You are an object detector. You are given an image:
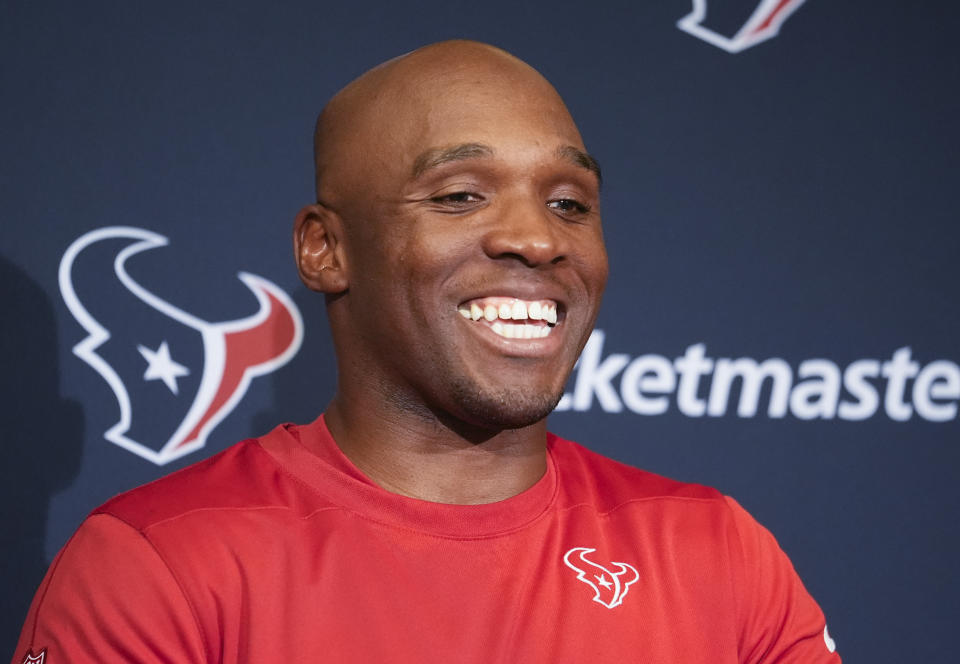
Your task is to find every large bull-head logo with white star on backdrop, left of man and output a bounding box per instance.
[59,226,303,465]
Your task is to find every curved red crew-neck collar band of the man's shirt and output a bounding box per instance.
[260,415,558,539]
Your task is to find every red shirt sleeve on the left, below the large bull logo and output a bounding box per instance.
[13,514,205,664]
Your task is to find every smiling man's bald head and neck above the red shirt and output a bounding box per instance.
[294,42,607,503]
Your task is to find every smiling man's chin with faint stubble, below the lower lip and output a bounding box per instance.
[451,378,563,429]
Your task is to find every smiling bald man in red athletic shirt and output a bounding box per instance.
[14,41,839,664]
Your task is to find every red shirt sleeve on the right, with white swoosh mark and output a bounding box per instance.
[726,497,840,664]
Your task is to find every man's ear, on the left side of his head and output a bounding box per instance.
[293,203,349,295]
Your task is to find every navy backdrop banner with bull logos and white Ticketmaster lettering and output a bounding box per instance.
[0,0,960,662]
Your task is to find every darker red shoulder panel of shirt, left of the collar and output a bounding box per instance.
[93,428,298,531]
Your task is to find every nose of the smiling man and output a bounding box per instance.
[484,197,566,267]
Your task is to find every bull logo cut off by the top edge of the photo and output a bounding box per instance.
[677,0,805,53]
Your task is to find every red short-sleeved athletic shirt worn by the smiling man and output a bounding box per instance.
[13,417,840,664]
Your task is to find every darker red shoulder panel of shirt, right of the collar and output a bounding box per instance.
[548,434,729,512]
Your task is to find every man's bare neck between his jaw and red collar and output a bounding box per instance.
[325,395,546,505]
